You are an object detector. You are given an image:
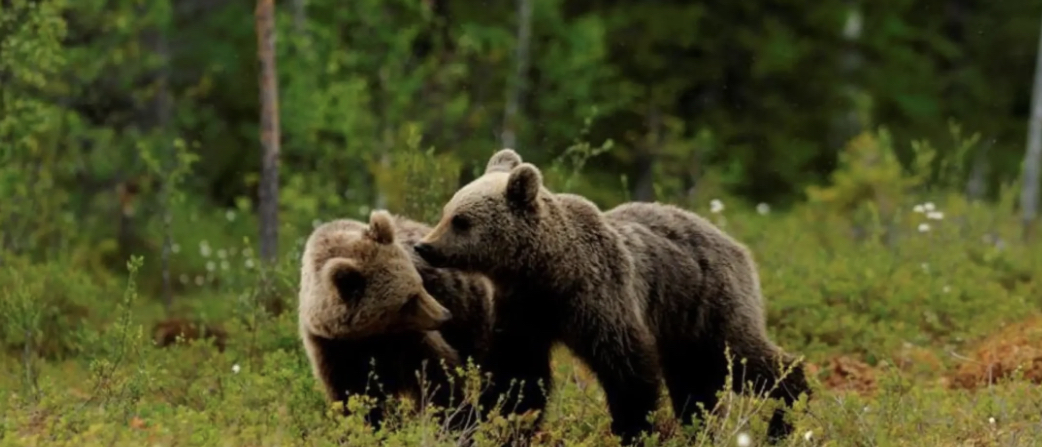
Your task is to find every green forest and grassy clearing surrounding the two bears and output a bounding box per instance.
[6,0,1042,447]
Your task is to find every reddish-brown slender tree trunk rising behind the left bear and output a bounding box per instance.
[255,0,279,264]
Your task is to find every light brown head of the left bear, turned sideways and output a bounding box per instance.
[300,210,451,339]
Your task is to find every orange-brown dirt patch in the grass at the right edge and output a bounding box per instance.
[950,317,1042,390]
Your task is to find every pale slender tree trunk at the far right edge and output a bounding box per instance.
[1020,14,1042,239]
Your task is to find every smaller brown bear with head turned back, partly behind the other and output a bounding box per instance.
[299,210,494,428]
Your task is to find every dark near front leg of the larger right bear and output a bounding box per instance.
[565,306,660,445]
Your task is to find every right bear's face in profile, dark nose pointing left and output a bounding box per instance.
[416,149,546,275]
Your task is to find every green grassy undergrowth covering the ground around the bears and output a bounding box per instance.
[6,130,1042,446]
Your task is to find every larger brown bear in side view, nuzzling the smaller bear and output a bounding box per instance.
[416,149,810,444]
